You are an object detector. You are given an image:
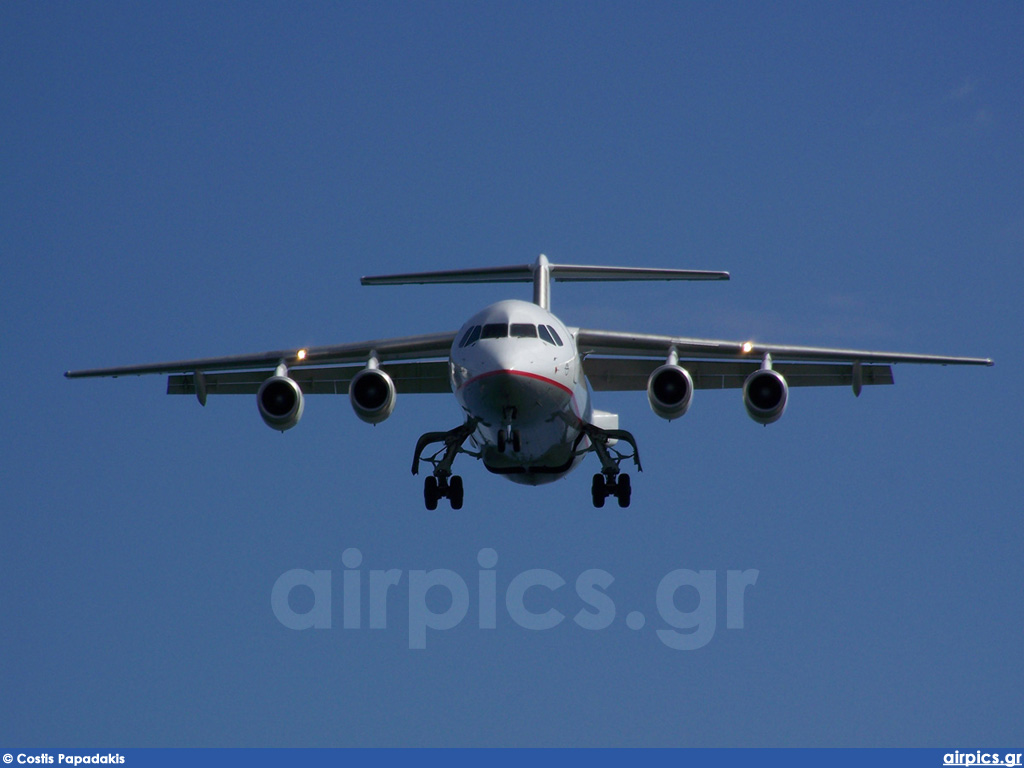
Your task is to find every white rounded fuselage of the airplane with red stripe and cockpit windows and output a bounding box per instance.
[449,300,592,485]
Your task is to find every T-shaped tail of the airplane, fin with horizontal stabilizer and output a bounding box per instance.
[359,253,729,310]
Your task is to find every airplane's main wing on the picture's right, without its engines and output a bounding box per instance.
[575,329,992,390]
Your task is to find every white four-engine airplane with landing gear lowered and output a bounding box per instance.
[65,254,992,510]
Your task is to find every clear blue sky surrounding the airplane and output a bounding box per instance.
[0,2,1024,749]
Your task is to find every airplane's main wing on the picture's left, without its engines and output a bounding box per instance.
[65,332,456,394]
